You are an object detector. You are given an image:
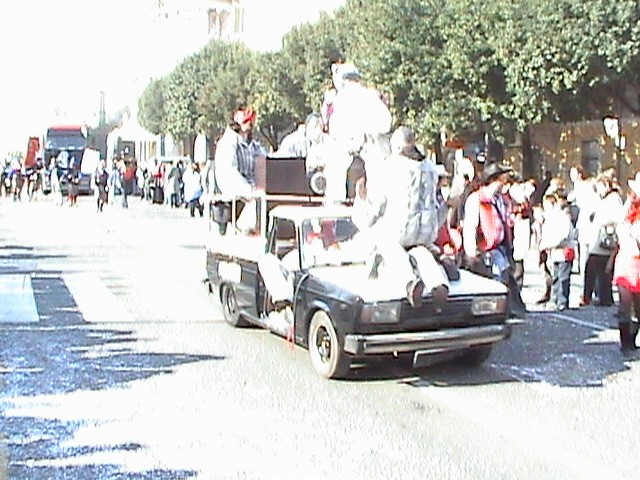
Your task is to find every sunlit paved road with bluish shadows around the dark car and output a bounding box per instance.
[0,193,640,480]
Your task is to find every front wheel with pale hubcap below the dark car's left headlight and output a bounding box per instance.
[308,311,351,378]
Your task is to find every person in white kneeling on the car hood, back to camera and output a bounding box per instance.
[353,127,450,310]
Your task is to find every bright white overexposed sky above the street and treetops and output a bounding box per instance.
[0,0,344,159]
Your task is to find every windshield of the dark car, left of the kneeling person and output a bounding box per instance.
[301,217,369,268]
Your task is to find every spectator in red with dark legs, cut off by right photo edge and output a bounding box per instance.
[612,172,640,350]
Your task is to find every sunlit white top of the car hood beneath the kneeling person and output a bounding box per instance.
[309,265,507,302]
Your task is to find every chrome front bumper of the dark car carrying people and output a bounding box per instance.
[344,324,511,355]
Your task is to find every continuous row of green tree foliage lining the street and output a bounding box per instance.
[139,0,640,156]
